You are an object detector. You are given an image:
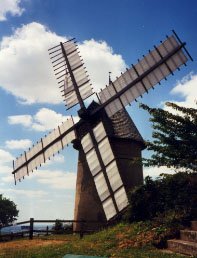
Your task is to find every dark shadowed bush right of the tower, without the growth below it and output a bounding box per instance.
[127,172,197,222]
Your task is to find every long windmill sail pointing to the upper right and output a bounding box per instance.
[99,35,190,117]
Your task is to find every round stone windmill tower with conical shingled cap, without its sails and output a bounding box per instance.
[74,102,145,230]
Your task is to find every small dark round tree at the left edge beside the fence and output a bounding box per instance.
[0,194,19,226]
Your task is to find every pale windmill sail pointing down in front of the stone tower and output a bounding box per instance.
[81,122,128,220]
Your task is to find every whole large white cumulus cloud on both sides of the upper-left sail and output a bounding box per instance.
[0,22,126,104]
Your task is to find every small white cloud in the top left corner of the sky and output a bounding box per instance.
[0,0,25,21]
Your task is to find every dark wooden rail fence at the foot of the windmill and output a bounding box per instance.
[0,218,107,240]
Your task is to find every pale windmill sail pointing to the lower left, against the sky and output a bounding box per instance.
[12,117,76,183]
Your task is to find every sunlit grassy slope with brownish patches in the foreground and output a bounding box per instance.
[0,223,189,258]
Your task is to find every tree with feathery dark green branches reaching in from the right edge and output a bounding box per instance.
[141,102,197,171]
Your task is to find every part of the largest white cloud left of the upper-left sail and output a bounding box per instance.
[0,22,65,104]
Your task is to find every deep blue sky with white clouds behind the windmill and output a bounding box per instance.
[0,0,197,221]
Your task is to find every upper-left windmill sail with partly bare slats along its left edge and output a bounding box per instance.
[49,39,94,108]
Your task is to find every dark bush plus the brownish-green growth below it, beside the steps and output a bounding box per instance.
[124,172,197,248]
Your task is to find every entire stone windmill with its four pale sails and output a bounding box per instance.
[12,31,192,230]
